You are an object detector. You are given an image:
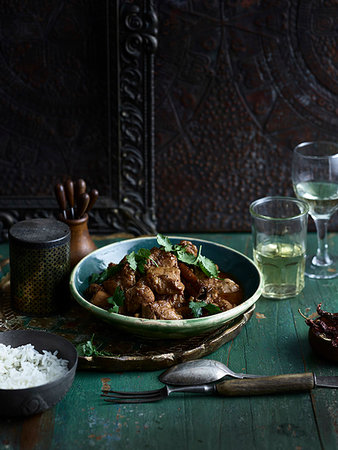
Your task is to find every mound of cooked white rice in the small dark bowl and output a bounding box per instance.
[0,344,68,389]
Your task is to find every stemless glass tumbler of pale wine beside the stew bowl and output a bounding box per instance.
[250,197,309,299]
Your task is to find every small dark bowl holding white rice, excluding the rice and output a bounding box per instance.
[0,330,78,417]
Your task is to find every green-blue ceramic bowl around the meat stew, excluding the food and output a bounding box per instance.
[70,236,262,339]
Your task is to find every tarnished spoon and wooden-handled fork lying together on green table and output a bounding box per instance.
[101,360,338,404]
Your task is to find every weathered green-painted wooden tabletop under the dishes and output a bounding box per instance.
[0,234,338,450]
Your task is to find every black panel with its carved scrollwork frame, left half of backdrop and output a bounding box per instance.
[0,0,157,241]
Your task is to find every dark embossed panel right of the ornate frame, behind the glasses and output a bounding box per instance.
[155,0,338,231]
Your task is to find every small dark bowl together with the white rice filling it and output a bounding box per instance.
[0,330,78,417]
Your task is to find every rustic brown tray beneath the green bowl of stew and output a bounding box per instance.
[0,275,255,372]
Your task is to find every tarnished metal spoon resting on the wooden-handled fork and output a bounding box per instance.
[159,359,261,386]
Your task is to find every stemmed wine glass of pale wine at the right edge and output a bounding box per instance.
[292,141,338,279]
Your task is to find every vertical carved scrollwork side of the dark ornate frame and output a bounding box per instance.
[119,1,157,232]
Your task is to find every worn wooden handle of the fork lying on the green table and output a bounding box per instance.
[216,373,315,396]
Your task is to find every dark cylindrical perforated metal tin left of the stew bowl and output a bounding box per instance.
[9,219,70,316]
